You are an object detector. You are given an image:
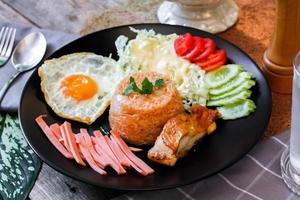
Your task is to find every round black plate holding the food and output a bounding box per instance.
[19,24,271,190]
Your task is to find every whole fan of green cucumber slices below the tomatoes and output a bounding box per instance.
[205,64,256,120]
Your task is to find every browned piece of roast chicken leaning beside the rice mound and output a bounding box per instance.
[148,105,220,166]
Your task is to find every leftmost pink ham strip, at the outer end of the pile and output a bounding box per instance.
[35,115,73,159]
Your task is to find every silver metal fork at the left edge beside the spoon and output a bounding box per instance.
[0,26,16,66]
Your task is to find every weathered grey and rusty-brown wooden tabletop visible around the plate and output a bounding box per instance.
[0,0,291,200]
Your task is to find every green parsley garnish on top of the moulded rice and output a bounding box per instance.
[123,76,164,96]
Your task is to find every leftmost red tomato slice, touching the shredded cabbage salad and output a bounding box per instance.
[174,33,194,56]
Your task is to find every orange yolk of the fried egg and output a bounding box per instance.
[60,74,97,101]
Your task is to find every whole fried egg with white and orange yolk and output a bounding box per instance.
[38,53,123,124]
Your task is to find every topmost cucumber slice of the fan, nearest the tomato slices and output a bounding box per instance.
[205,64,244,88]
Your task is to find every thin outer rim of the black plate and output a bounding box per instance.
[18,23,272,191]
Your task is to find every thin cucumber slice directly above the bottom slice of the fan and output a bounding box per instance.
[206,90,252,106]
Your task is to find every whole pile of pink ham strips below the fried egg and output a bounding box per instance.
[35,115,154,176]
